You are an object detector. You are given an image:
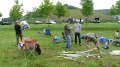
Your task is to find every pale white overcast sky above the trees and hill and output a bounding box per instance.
[0,0,118,17]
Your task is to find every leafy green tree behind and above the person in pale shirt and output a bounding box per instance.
[81,0,94,22]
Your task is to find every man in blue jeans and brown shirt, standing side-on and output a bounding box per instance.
[64,21,71,49]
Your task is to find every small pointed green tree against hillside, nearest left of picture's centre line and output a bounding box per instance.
[55,1,69,23]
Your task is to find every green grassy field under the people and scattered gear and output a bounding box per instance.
[0,24,120,67]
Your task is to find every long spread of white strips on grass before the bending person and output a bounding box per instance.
[58,49,100,60]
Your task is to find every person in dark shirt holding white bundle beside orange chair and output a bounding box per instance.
[14,21,22,45]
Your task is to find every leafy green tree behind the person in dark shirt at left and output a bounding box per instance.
[9,0,23,22]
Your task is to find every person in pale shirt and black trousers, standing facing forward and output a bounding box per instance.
[74,20,82,46]
